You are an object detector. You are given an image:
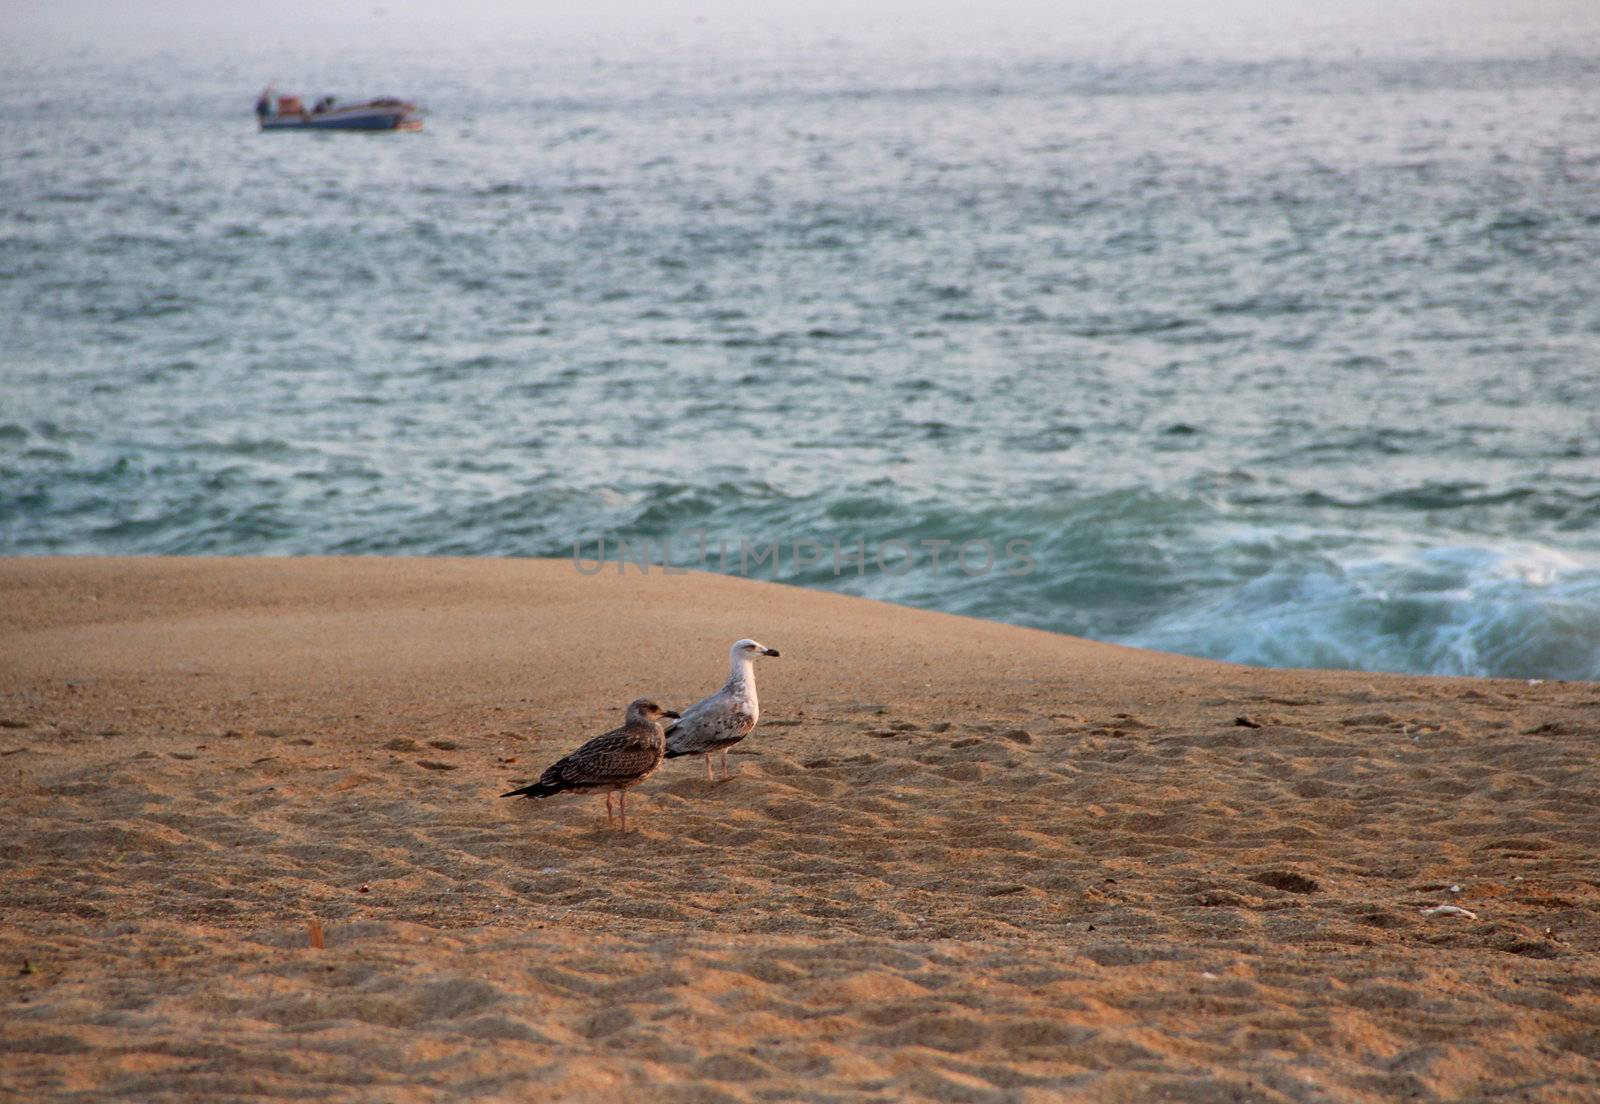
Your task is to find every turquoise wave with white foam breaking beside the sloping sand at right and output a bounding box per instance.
[528,485,1600,678]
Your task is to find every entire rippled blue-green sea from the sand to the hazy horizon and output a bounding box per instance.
[0,3,1600,678]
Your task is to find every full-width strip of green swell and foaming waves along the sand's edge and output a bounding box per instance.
[0,454,1600,678]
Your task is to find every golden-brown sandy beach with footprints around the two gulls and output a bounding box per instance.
[0,558,1600,1104]
